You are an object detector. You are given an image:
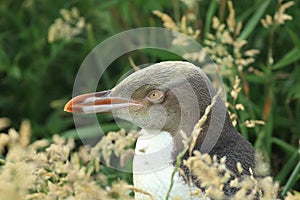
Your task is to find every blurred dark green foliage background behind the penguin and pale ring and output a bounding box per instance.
[0,0,300,195]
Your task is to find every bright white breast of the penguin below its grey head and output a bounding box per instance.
[133,129,204,200]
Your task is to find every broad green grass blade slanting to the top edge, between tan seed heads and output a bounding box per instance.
[240,0,271,40]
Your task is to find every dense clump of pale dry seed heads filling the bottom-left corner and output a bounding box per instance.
[0,121,138,200]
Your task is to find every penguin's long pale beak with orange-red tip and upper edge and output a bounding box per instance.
[64,90,143,114]
